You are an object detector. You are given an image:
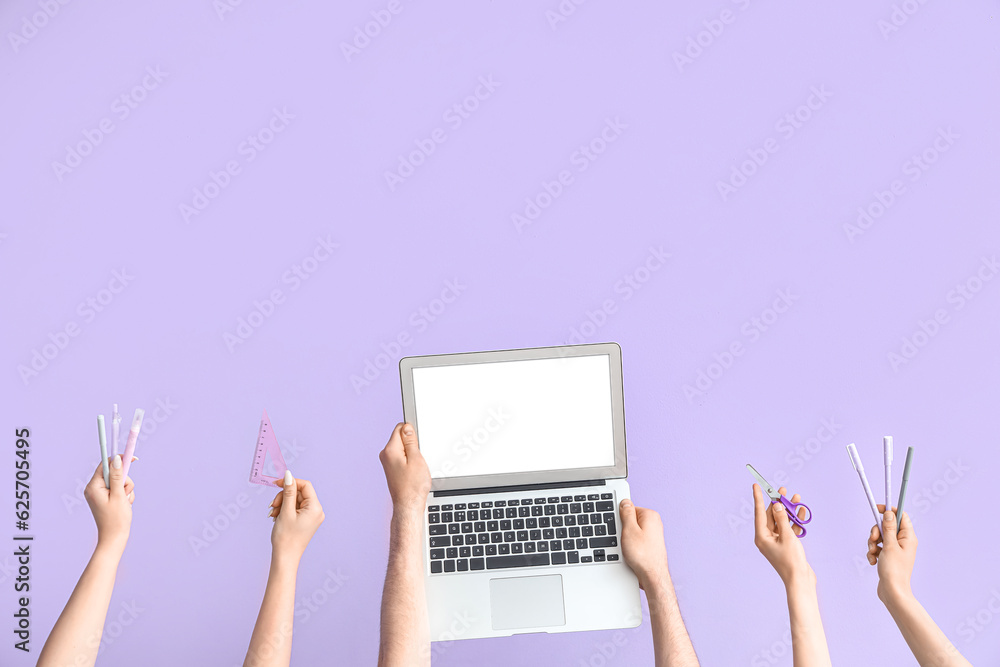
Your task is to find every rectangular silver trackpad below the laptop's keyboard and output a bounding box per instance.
[490,574,566,630]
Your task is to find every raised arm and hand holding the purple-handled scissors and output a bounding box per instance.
[753,484,831,667]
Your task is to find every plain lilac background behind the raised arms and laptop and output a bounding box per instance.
[0,0,1000,666]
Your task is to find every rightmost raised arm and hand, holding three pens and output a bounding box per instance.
[868,505,972,667]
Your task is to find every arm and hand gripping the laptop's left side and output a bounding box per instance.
[378,424,431,667]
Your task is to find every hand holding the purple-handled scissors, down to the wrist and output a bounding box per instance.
[753,484,815,587]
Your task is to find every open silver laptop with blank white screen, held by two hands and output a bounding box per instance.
[399,343,642,641]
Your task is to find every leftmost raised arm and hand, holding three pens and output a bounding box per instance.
[38,455,135,667]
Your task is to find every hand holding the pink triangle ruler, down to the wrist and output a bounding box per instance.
[267,470,326,562]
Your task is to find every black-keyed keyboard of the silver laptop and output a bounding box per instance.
[427,492,621,574]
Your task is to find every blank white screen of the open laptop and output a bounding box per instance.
[413,354,615,479]
